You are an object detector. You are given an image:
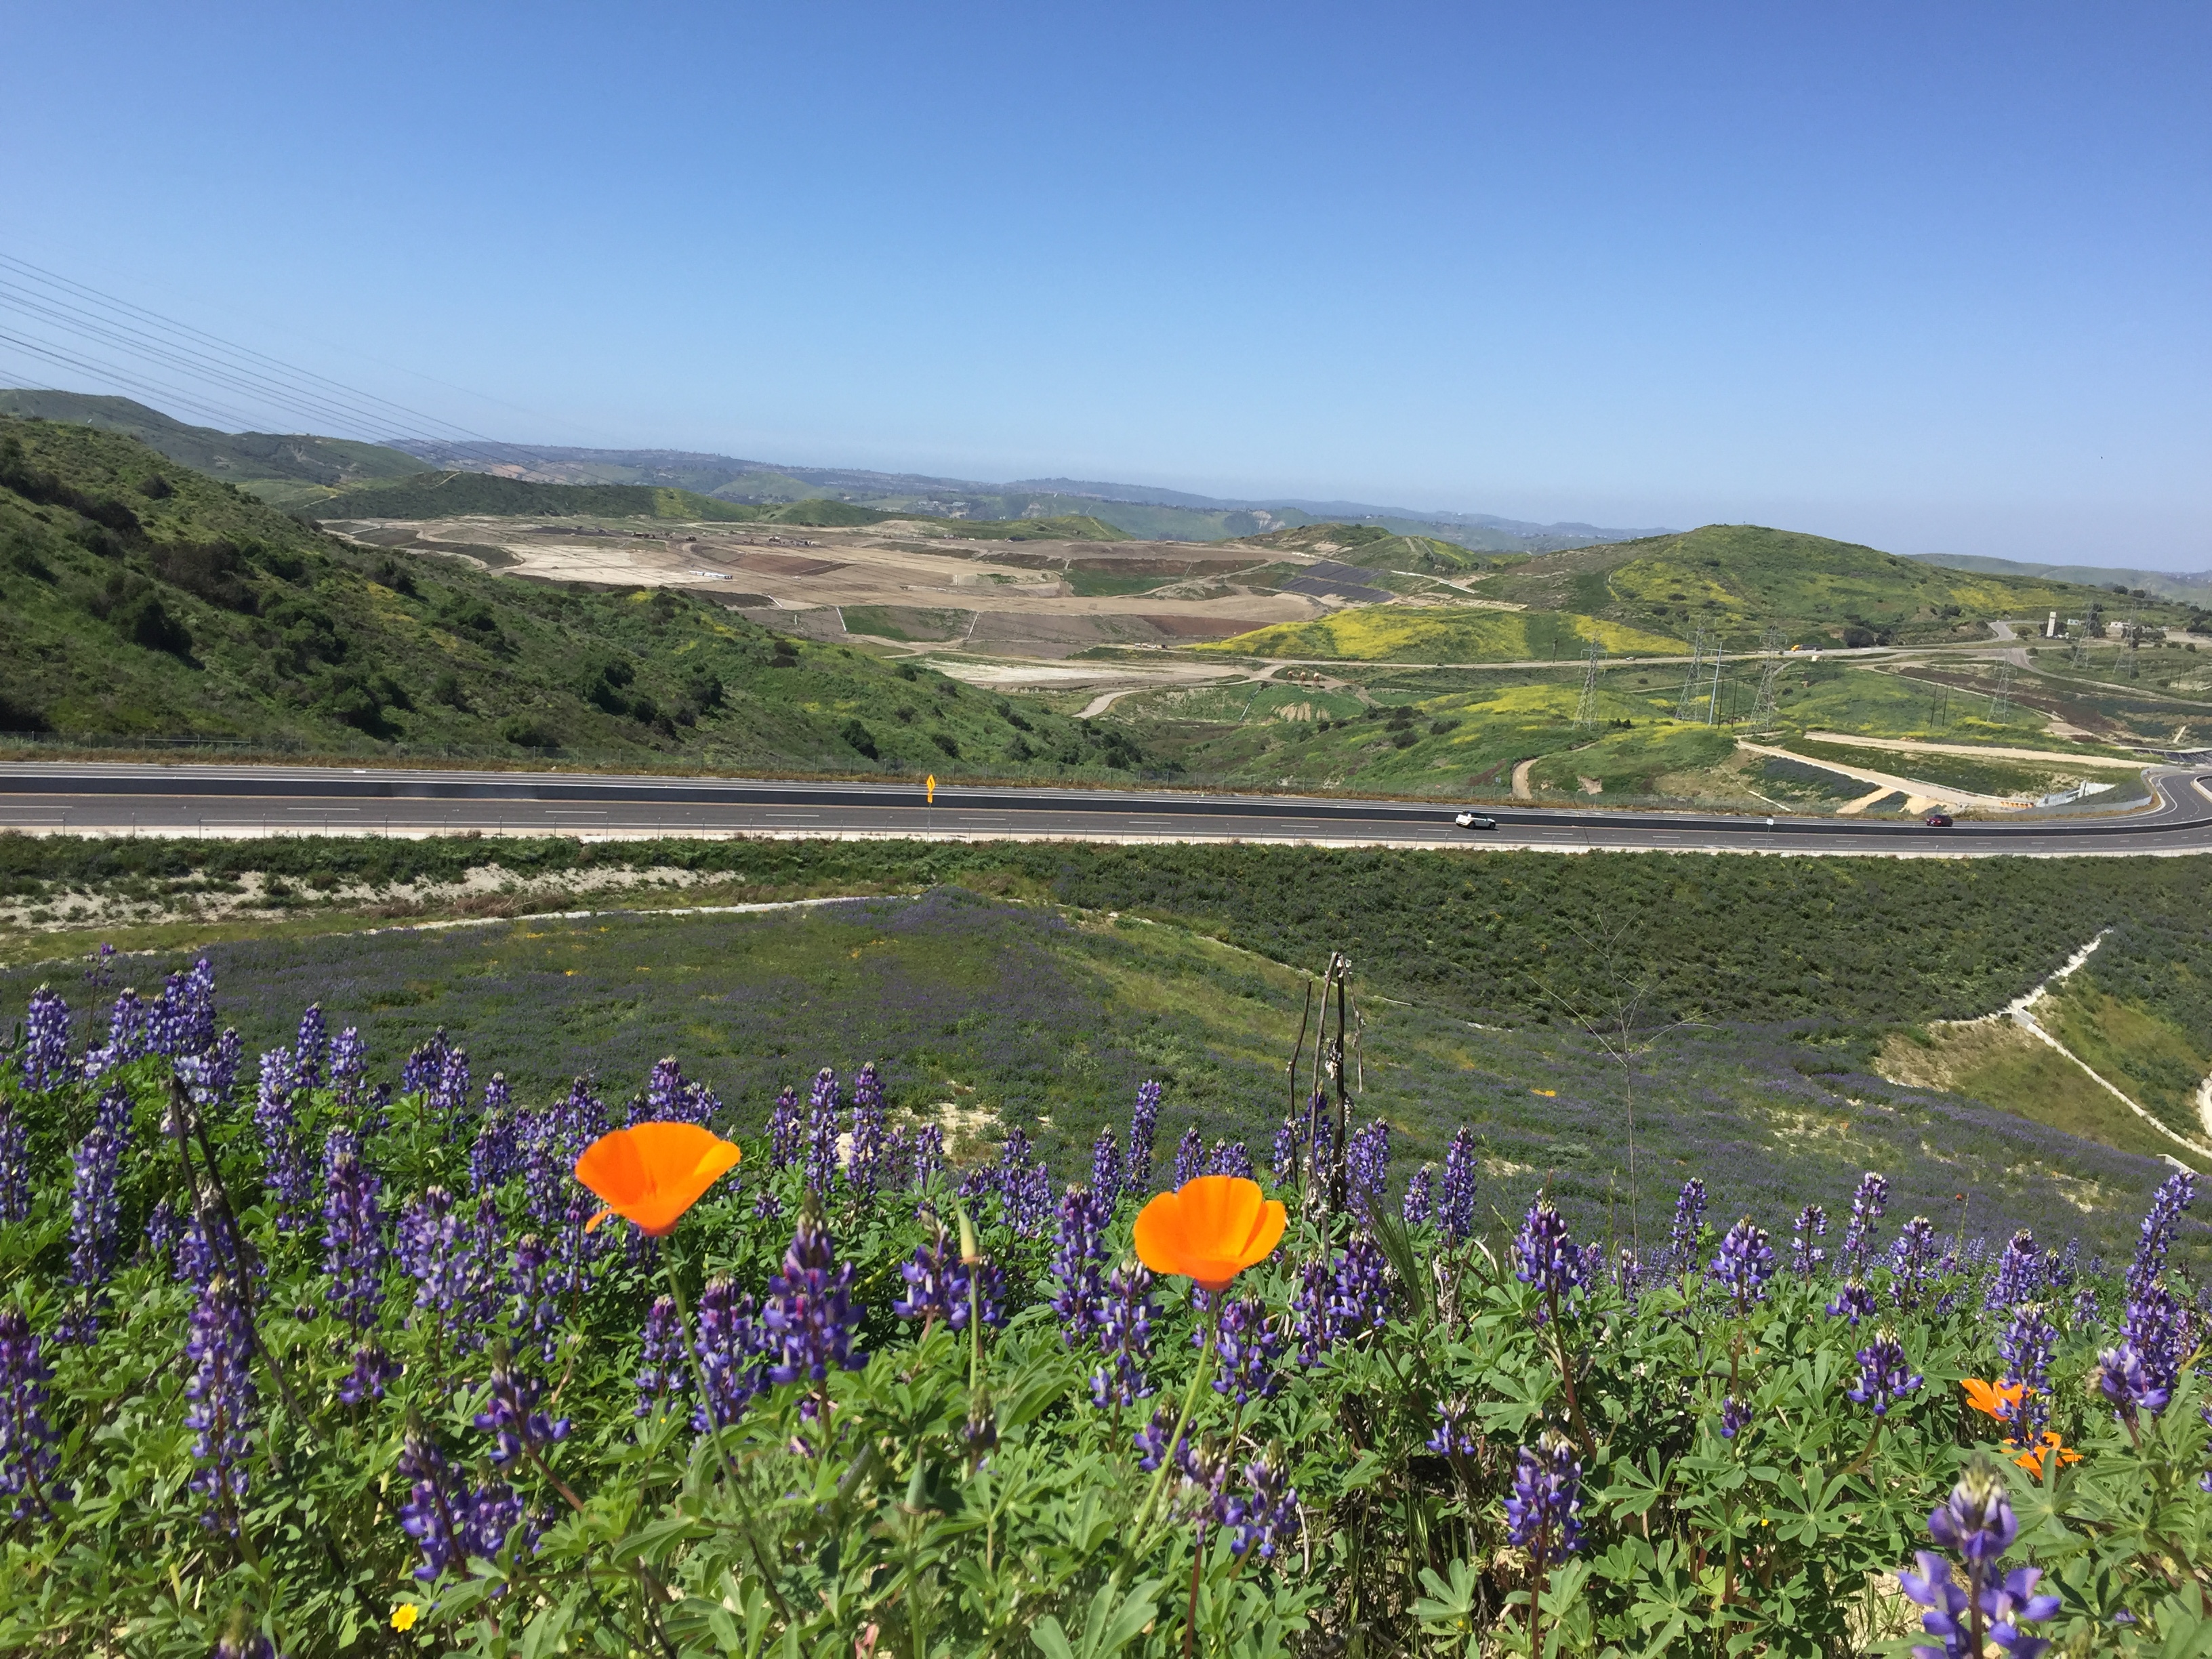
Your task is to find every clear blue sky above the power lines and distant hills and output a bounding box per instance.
[0,0,2212,569]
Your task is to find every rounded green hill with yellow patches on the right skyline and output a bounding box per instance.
[1482,525,2181,648]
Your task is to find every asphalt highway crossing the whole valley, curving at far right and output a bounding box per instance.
[0,761,2212,858]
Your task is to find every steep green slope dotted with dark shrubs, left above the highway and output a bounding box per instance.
[0,418,1141,777]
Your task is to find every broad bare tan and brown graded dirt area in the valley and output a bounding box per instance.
[329,518,1360,657]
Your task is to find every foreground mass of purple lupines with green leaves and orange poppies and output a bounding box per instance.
[0,966,2212,1659]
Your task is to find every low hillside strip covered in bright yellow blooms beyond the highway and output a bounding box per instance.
[1197,604,1683,663]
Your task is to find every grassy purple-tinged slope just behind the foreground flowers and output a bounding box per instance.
[0,889,2194,1243]
